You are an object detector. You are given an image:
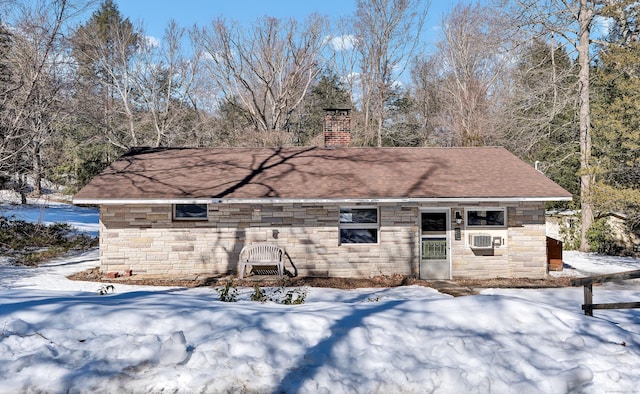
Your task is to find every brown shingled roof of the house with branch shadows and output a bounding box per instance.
[74,147,571,204]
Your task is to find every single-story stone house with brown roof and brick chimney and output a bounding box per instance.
[74,109,571,279]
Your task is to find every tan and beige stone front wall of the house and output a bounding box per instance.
[100,203,546,278]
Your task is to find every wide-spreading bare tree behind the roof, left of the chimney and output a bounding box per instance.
[194,15,326,137]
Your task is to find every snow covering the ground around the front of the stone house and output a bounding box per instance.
[0,202,640,393]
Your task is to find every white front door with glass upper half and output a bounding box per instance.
[420,209,451,279]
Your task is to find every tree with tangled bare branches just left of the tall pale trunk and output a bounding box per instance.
[496,37,578,163]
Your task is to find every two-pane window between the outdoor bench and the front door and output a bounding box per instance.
[340,208,378,244]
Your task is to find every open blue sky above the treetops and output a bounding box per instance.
[115,0,471,45]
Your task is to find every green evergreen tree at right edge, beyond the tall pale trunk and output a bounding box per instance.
[593,1,640,222]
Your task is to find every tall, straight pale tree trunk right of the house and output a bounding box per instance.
[578,0,594,252]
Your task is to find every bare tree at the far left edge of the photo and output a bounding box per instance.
[0,0,86,202]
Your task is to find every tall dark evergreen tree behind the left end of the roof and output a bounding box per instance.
[59,0,141,191]
